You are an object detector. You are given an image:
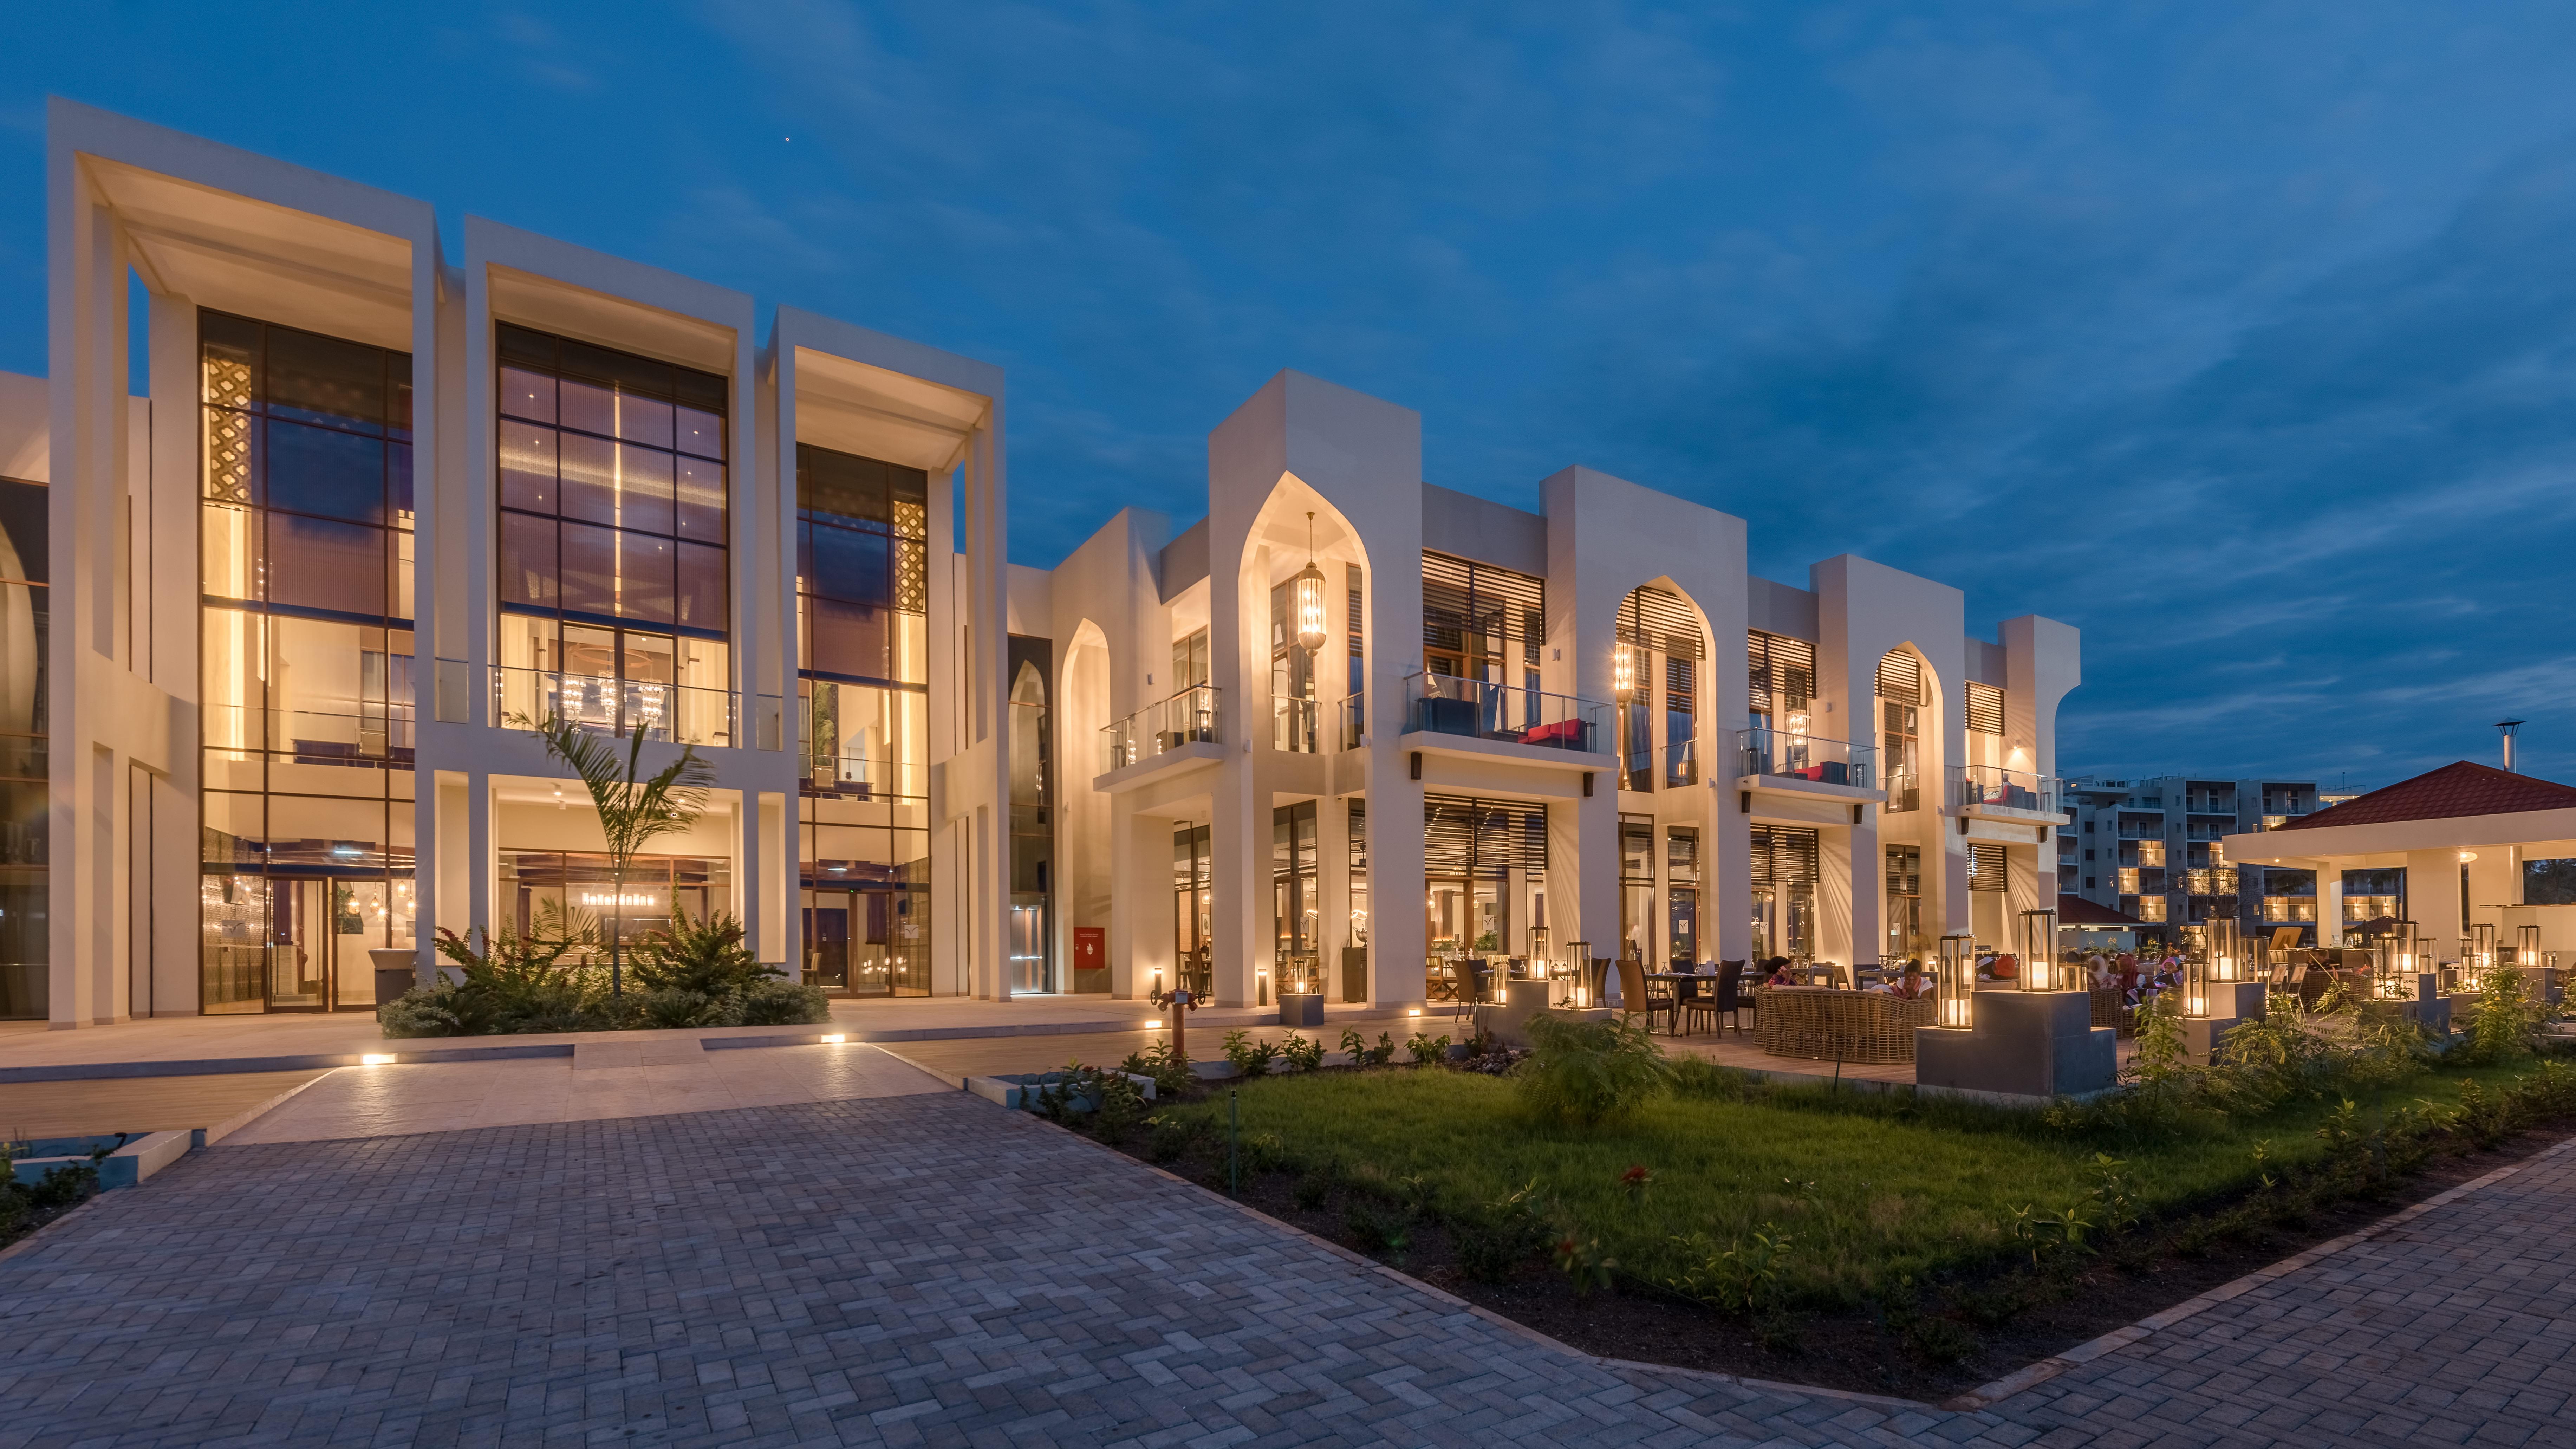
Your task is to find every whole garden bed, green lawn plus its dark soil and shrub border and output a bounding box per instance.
[1074,1047,2571,1403]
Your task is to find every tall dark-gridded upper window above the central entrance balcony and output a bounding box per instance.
[497,322,739,745]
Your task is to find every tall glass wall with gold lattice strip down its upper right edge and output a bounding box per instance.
[796,443,937,995]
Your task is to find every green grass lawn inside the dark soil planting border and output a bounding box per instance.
[1167,1065,2530,1307]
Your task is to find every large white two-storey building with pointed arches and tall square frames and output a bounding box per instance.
[0,100,2079,1026]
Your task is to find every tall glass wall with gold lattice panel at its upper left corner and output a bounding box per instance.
[199,312,412,1013]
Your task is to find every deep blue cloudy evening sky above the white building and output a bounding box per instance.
[0,0,2576,786]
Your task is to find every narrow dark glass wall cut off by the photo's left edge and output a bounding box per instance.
[0,477,52,1021]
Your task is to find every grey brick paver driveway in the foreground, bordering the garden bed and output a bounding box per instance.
[0,1093,2571,1447]
